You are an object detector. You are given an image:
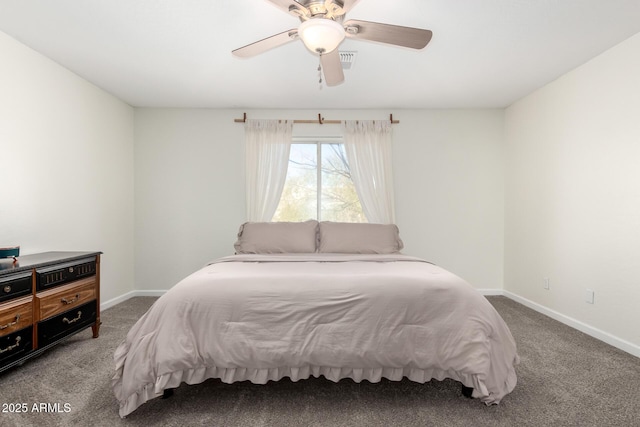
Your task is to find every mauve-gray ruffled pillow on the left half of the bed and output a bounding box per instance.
[234,220,318,254]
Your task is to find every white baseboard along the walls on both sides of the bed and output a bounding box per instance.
[100,289,640,357]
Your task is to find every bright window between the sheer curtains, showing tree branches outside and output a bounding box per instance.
[273,140,367,222]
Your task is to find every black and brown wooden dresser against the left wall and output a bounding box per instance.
[0,252,101,372]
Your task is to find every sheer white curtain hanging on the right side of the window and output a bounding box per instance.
[342,120,395,224]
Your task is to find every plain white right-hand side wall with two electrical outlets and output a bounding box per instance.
[505,34,640,349]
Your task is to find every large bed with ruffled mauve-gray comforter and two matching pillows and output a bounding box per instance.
[112,221,518,417]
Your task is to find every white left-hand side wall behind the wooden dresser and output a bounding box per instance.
[0,32,134,301]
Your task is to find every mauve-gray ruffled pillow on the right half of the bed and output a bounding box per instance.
[318,221,404,254]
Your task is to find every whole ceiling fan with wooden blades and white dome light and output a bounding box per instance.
[232,0,433,86]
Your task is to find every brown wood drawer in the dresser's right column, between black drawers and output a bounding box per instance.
[36,277,96,320]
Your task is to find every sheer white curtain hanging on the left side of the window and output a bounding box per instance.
[245,120,293,221]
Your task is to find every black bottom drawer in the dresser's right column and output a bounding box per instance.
[38,300,96,347]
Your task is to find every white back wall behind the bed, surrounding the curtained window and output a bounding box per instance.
[135,109,504,290]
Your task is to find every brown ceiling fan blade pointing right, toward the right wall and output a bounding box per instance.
[344,19,433,49]
